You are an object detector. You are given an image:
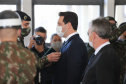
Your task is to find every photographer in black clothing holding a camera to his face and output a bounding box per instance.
[28,27,59,84]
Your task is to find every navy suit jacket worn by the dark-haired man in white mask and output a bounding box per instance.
[53,34,88,84]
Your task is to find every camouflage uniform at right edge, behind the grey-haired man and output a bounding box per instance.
[110,25,126,84]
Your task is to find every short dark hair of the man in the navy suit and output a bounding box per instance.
[59,12,78,30]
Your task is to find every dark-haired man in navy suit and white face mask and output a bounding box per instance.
[53,12,88,84]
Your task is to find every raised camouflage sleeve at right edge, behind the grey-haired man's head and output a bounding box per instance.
[109,25,126,42]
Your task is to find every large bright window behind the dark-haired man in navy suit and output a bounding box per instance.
[34,5,100,43]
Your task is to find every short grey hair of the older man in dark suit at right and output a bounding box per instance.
[91,17,112,39]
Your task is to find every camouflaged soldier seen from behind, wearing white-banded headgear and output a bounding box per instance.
[0,10,60,84]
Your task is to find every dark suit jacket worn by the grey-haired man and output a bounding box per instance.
[82,45,120,84]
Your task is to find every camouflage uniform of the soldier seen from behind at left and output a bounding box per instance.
[0,42,47,84]
